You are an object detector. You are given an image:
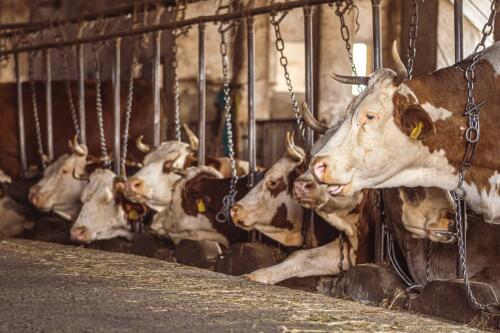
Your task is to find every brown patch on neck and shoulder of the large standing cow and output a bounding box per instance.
[406,60,500,192]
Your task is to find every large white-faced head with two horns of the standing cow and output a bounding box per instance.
[310,45,456,195]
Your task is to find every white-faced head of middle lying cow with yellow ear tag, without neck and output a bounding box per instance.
[147,166,229,246]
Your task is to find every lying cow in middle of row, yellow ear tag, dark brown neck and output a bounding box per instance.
[151,166,248,247]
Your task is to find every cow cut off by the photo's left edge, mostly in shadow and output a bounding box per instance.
[0,169,34,238]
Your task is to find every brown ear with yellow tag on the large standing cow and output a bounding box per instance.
[396,104,436,140]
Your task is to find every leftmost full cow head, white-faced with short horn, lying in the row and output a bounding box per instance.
[29,137,92,220]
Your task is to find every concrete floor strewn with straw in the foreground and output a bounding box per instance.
[0,239,486,333]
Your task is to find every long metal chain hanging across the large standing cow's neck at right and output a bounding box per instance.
[450,0,496,310]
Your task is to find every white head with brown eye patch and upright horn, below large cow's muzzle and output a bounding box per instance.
[231,133,305,246]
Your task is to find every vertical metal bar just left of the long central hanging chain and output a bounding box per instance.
[198,23,207,165]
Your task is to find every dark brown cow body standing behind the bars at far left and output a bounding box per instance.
[0,80,166,179]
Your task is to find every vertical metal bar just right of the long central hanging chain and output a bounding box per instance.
[247,16,257,188]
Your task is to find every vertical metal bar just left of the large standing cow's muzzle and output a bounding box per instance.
[304,6,316,247]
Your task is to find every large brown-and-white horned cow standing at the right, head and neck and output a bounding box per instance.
[310,43,500,223]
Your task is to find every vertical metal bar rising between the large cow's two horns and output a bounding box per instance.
[371,0,385,263]
